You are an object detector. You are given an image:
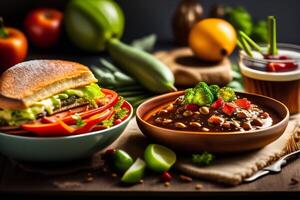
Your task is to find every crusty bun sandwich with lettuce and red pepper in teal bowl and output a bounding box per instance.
[0,60,128,135]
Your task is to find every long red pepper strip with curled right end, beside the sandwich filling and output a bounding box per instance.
[42,89,118,124]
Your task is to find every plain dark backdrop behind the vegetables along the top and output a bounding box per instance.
[0,0,300,44]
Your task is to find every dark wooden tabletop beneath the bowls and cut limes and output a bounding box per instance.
[0,43,300,200]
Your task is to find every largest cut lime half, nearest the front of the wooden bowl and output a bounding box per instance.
[144,144,176,172]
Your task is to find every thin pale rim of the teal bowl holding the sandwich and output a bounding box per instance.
[0,101,133,141]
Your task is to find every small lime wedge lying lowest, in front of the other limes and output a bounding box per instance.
[121,158,146,183]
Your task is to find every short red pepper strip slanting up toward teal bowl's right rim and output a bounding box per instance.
[73,111,115,135]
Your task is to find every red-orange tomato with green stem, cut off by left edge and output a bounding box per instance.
[0,18,28,74]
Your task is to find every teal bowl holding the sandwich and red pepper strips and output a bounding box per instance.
[0,102,133,162]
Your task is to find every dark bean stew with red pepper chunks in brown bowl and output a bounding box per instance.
[145,82,279,132]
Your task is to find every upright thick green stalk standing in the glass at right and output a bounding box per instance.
[268,16,278,55]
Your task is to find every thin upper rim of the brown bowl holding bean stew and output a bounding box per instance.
[136,90,290,136]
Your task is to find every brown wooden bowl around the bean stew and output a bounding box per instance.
[136,91,289,153]
